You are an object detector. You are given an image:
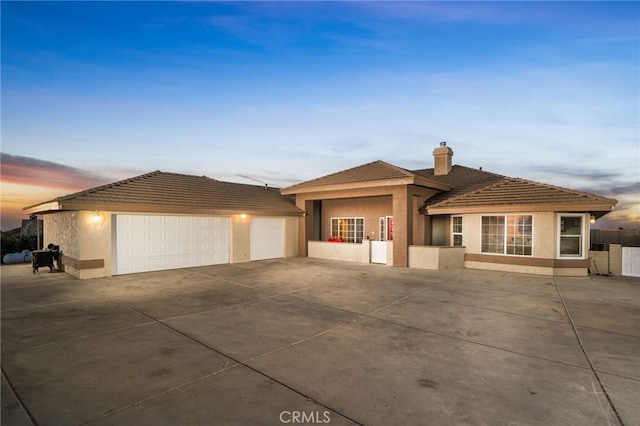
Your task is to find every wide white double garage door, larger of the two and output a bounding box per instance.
[113,215,229,274]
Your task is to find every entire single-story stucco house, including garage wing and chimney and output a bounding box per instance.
[26,142,617,278]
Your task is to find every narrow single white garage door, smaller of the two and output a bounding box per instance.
[251,217,284,260]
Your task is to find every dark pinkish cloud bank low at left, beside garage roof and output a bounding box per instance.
[0,153,112,191]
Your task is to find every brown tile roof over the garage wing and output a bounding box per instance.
[26,171,302,215]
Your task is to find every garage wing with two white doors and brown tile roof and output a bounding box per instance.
[26,171,303,278]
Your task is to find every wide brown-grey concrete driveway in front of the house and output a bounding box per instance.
[0,258,640,425]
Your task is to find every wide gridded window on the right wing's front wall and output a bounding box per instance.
[482,215,533,256]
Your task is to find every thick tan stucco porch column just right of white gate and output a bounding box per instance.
[393,186,413,268]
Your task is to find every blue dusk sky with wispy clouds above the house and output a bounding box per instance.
[0,1,640,231]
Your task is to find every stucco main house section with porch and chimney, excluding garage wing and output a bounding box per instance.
[282,142,617,275]
